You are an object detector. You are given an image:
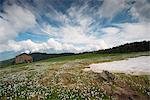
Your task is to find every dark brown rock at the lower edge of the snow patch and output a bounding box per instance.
[100,71,115,81]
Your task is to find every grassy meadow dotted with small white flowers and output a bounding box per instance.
[0,52,150,100]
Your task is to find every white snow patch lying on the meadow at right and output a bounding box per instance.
[89,56,150,75]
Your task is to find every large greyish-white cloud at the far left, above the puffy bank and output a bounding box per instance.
[0,5,36,43]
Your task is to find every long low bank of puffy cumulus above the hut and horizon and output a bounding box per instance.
[0,38,103,53]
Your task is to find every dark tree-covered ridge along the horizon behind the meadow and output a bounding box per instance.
[0,41,150,66]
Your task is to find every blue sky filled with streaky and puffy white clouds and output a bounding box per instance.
[0,0,150,60]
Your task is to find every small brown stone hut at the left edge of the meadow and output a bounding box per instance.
[15,53,33,64]
